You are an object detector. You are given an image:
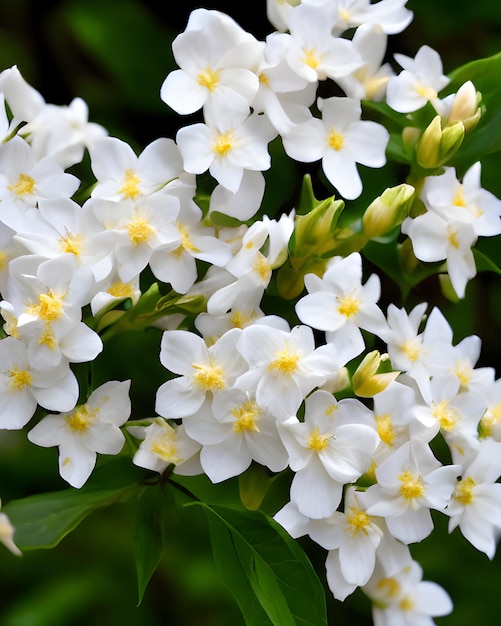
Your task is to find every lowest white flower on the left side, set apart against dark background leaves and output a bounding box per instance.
[28,380,131,488]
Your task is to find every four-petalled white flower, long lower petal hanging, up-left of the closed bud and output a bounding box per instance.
[283,97,389,200]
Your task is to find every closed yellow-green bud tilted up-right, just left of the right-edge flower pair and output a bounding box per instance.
[362,183,415,239]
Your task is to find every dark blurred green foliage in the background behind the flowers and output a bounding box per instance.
[0,0,501,626]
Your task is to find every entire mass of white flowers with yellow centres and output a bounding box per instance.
[0,0,501,626]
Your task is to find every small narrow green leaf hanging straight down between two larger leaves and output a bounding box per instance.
[134,485,164,606]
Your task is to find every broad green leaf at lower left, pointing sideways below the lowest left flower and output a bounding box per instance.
[2,459,145,550]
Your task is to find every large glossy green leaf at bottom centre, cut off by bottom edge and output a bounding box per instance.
[190,502,327,626]
